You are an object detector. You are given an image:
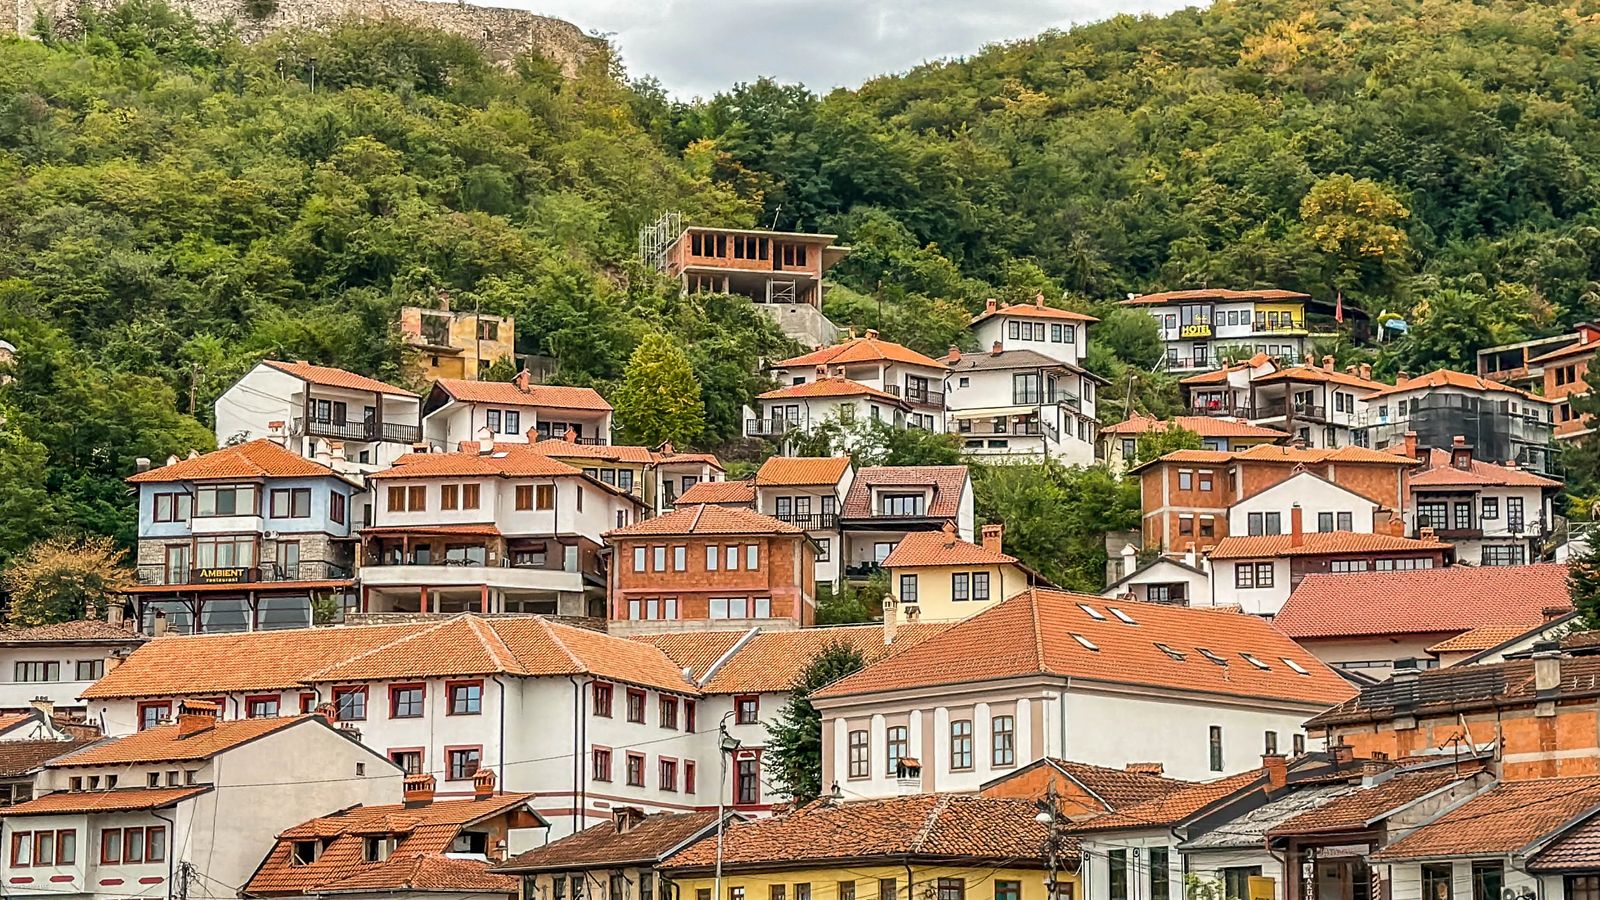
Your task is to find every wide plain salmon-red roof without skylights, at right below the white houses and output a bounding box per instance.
[1272,560,1571,645]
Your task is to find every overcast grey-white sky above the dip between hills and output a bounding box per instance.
[518,0,1190,99]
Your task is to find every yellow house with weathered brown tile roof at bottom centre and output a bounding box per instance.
[659,794,1078,900]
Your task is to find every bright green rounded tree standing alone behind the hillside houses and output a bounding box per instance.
[616,333,706,447]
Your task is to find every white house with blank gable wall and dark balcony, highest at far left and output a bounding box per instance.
[216,359,422,472]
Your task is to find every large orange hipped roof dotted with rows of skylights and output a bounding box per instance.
[818,589,1355,705]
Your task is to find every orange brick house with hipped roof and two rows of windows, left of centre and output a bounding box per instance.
[605,503,816,631]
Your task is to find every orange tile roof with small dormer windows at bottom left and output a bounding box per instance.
[240,794,533,897]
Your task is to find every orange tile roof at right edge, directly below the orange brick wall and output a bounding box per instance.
[1370,775,1600,862]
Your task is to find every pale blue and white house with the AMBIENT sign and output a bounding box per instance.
[128,439,365,634]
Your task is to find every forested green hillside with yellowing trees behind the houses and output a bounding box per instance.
[0,0,1600,589]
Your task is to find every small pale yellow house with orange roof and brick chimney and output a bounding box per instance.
[883,525,1050,623]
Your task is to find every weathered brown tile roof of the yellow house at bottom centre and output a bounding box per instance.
[661,794,1077,871]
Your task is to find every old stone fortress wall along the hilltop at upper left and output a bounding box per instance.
[9,0,602,77]
